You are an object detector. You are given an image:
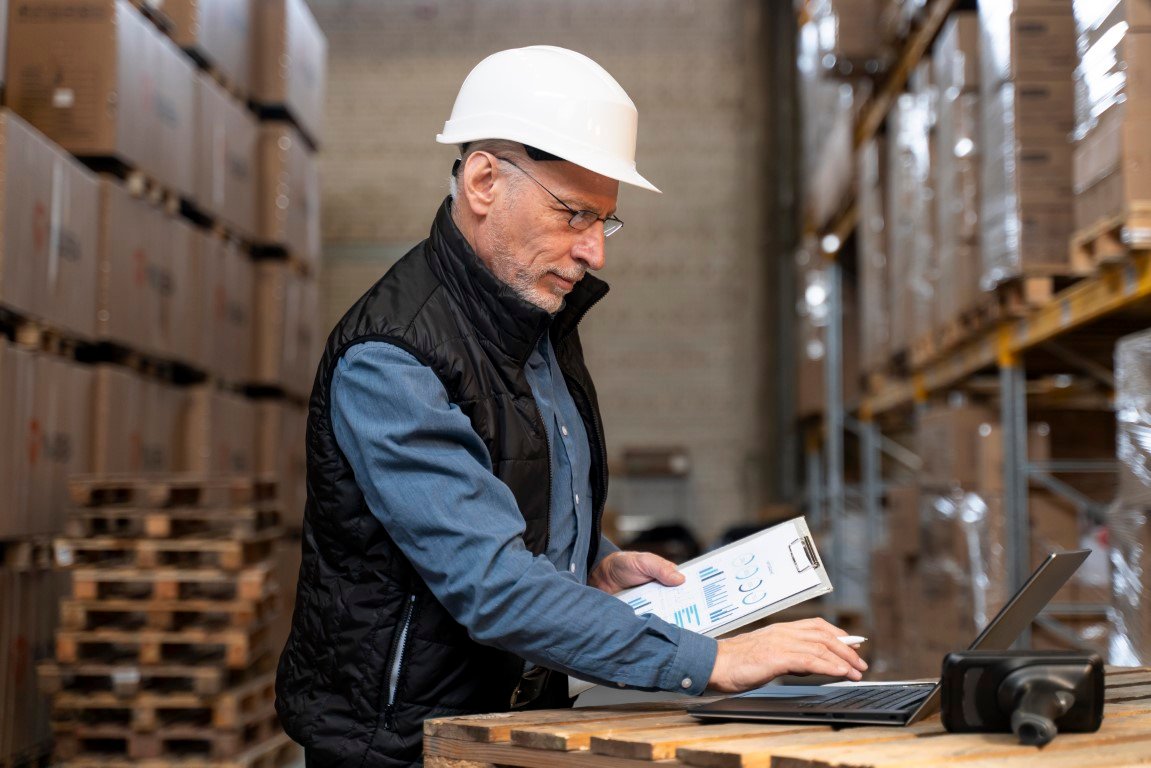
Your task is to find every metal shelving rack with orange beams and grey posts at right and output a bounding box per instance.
[806,0,1137,642]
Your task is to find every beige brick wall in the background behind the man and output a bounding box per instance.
[311,0,770,538]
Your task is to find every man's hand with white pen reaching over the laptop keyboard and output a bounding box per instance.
[704,617,867,693]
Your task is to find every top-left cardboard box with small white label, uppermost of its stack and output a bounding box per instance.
[7,0,195,193]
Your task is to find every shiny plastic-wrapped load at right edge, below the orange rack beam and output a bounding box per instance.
[1106,332,1151,664]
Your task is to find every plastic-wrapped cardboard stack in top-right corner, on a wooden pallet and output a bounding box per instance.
[1073,0,1151,229]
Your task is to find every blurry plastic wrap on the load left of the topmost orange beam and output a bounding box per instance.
[796,23,857,227]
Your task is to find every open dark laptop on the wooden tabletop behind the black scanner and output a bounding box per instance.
[687,549,1091,725]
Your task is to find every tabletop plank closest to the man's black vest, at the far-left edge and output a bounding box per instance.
[424,699,716,743]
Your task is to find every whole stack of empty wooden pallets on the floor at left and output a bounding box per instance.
[39,477,297,767]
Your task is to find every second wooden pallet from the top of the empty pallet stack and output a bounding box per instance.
[64,501,283,539]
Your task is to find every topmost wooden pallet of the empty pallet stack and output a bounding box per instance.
[69,474,276,508]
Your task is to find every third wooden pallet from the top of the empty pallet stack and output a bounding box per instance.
[55,529,283,571]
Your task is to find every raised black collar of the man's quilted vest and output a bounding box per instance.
[428,197,608,367]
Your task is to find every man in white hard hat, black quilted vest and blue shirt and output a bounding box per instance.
[276,46,866,766]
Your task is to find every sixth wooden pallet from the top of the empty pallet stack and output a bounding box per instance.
[56,626,267,669]
